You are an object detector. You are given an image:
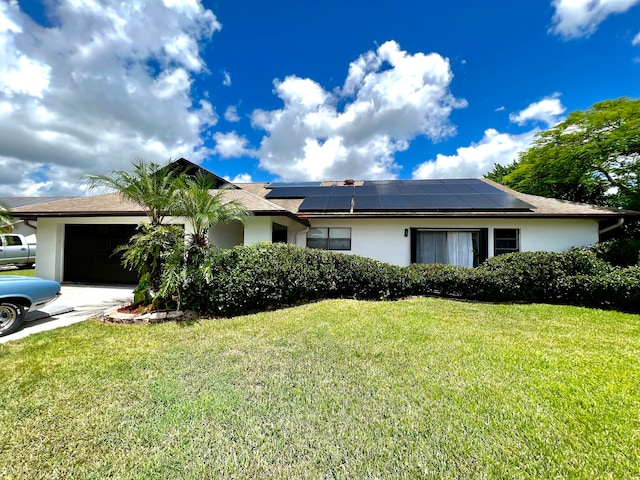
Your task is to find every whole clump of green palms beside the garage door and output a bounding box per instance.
[85,160,247,306]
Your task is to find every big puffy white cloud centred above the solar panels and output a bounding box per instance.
[252,41,466,180]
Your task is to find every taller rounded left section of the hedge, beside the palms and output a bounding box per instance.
[184,243,408,316]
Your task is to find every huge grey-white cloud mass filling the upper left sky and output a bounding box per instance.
[0,0,221,195]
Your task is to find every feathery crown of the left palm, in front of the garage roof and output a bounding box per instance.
[84,159,180,225]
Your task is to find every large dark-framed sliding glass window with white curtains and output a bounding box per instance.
[411,228,488,267]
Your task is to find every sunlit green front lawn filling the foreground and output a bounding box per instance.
[0,299,640,479]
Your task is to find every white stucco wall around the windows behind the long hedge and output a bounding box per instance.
[297,218,599,265]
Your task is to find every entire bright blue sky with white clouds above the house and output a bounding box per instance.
[0,0,640,195]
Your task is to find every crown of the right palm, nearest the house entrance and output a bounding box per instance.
[171,171,247,250]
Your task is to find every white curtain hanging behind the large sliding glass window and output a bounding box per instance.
[416,232,473,267]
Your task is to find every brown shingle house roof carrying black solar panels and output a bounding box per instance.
[0,158,640,225]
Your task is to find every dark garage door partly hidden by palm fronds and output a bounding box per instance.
[63,225,138,285]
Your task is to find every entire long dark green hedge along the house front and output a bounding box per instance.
[182,243,640,316]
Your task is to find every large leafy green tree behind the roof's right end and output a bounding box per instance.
[485,97,640,210]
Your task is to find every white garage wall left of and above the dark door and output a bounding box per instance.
[36,217,146,282]
